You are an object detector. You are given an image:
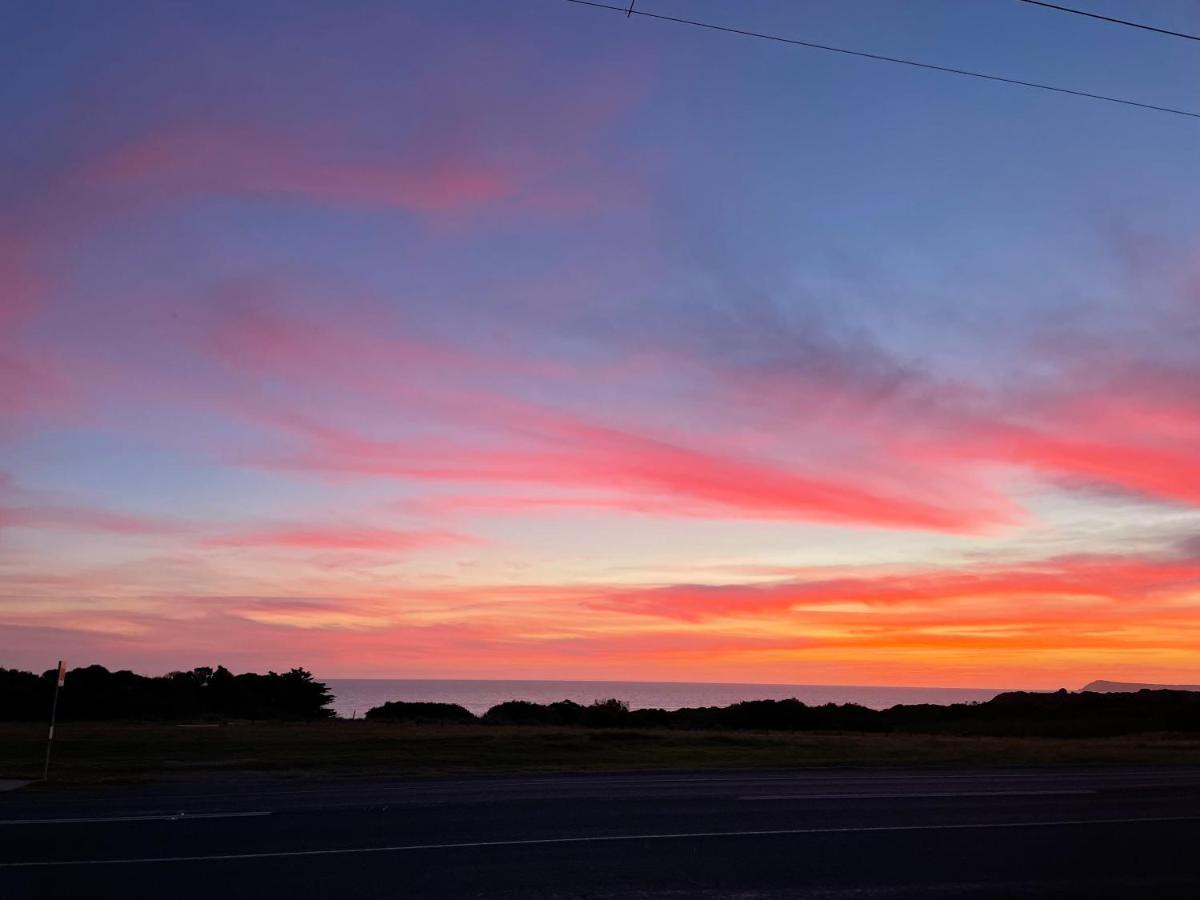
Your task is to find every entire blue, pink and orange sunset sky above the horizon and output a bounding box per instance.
[0,0,1200,688]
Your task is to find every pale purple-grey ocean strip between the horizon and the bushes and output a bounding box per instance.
[323,678,1002,718]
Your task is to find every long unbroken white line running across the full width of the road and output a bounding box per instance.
[0,816,1200,869]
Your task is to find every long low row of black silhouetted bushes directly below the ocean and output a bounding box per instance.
[366,690,1200,738]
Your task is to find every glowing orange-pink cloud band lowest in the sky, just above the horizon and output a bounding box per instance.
[9,554,1200,686]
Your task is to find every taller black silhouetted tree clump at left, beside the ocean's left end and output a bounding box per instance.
[0,666,334,721]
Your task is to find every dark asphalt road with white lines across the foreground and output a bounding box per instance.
[0,768,1200,900]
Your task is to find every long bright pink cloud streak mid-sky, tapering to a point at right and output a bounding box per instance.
[187,303,1019,532]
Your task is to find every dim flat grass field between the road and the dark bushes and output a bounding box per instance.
[7,721,1200,786]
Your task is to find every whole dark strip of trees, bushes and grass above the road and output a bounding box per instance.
[0,666,1200,785]
